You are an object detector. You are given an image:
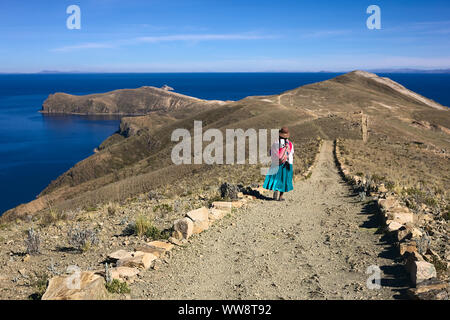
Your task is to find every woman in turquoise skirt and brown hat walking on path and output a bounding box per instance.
[263,127,294,201]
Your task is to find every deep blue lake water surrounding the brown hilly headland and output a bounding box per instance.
[0,73,450,215]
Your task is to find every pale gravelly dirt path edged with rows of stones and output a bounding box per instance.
[131,141,405,299]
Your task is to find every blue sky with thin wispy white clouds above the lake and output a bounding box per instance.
[0,0,450,72]
